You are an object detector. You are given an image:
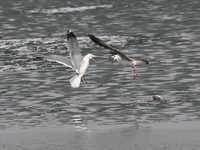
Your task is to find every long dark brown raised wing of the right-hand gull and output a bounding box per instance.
[88,34,131,60]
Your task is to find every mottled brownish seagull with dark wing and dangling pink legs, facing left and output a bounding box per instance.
[88,34,149,79]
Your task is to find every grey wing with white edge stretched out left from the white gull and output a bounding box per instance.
[44,55,74,69]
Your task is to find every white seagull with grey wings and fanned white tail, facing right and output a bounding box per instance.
[39,30,97,88]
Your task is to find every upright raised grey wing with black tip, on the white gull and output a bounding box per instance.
[67,30,83,71]
